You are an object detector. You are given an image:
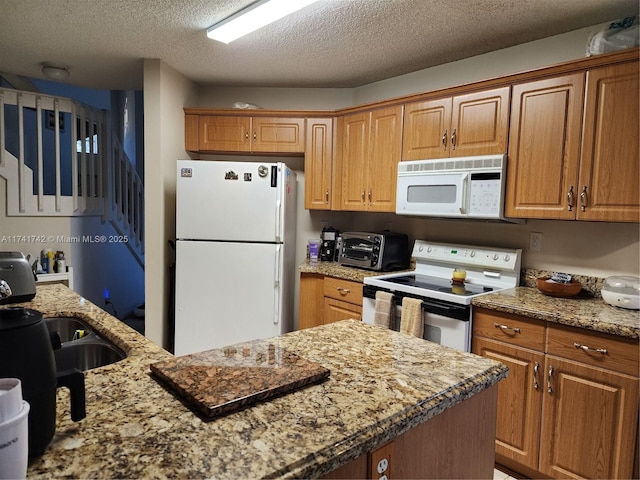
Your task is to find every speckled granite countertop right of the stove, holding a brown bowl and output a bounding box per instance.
[472,287,640,339]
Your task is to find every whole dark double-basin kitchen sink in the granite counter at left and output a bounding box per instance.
[44,317,127,372]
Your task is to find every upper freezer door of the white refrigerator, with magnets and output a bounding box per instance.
[176,160,295,242]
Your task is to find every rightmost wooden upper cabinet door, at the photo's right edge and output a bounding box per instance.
[576,62,640,222]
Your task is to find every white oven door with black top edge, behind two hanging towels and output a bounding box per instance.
[362,285,471,352]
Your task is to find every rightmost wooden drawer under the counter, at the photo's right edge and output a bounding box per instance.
[546,325,640,377]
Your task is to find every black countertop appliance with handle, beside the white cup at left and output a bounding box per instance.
[0,307,85,458]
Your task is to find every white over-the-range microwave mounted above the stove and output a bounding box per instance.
[396,154,517,221]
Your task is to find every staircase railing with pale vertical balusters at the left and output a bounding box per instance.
[0,88,144,266]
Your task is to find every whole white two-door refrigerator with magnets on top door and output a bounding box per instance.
[174,160,296,355]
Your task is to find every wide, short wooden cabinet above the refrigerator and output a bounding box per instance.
[185,115,305,153]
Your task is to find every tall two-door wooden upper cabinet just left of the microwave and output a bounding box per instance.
[333,105,402,212]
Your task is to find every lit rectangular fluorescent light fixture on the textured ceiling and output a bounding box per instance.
[207,0,317,43]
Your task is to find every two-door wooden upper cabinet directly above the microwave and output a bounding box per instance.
[402,87,510,160]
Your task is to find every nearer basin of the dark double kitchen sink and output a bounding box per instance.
[54,337,126,371]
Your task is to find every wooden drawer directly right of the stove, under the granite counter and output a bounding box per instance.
[473,308,546,352]
